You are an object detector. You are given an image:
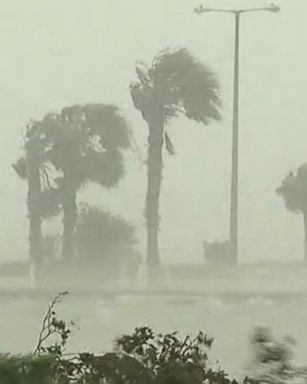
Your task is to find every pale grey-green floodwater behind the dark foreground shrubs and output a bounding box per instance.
[0,270,307,376]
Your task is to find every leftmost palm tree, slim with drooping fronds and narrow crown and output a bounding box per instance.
[12,121,58,266]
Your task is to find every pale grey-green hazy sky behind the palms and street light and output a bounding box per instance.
[0,0,307,261]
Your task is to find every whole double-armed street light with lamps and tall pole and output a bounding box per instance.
[195,4,280,264]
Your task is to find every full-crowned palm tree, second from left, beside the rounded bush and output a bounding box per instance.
[43,104,129,260]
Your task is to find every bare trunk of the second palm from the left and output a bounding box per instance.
[62,171,77,260]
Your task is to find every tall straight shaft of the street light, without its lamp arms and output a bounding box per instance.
[230,12,240,263]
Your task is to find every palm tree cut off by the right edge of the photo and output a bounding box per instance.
[276,163,307,262]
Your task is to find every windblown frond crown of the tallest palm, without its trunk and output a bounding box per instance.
[130,49,221,124]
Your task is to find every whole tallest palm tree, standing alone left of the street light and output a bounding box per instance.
[130,49,221,266]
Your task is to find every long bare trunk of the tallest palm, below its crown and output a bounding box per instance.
[145,110,164,267]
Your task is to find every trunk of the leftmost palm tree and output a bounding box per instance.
[27,161,43,266]
